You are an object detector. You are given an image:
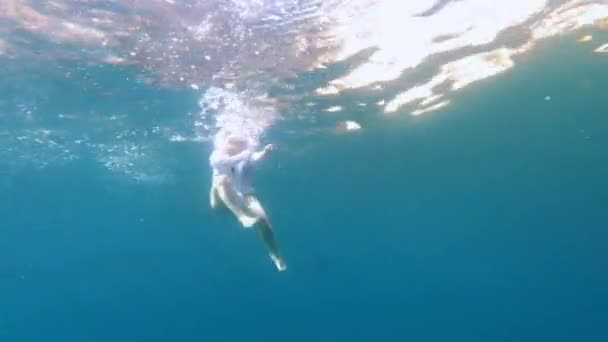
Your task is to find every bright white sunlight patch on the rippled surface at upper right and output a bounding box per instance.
[316,0,608,115]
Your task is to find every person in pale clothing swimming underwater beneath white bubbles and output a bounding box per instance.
[209,135,287,271]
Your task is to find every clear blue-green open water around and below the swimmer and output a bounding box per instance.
[0,33,608,341]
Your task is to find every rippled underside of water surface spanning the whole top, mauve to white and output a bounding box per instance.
[0,0,608,120]
